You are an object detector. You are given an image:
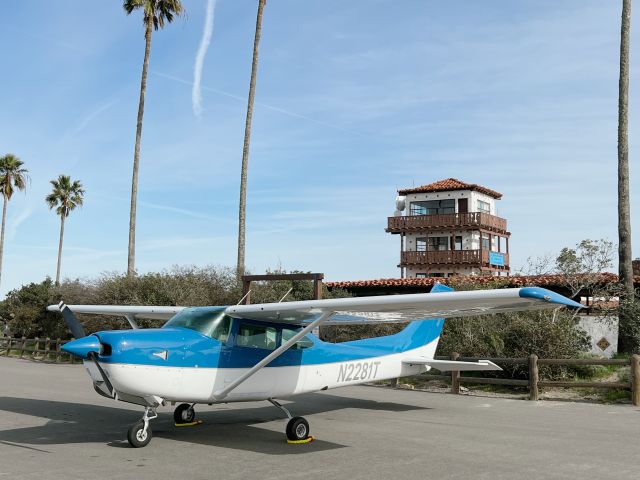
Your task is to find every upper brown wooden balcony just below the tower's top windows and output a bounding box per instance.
[387,212,508,235]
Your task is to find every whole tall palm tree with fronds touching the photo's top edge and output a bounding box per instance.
[122,0,183,277]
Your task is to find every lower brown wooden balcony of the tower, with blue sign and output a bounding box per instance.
[400,250,509,270]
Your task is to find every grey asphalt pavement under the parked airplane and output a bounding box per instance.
[0,357,640,480]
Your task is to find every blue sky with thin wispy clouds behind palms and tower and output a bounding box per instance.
[0,0,640,292]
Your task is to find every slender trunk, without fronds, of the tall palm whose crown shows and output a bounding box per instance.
[127,20,153,277]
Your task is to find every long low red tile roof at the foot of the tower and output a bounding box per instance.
[325,273,640,289]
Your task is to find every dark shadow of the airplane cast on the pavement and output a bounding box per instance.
[0,394,427,455]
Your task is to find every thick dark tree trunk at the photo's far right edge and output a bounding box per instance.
[618,0,634,351]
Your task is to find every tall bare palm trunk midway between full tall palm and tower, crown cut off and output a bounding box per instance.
[236,0,266,278]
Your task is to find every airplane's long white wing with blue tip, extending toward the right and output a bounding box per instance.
[226,287,583,325]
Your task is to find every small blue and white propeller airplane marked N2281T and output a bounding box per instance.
[47,284,582,447]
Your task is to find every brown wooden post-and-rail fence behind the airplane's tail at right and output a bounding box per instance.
[421,353,640,406]
